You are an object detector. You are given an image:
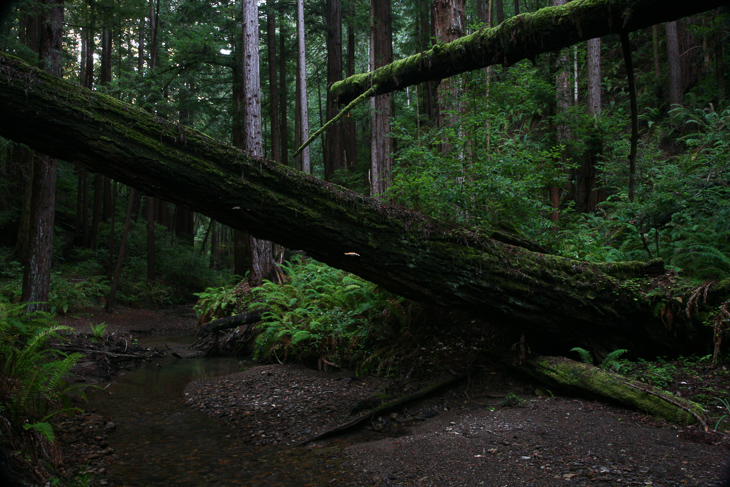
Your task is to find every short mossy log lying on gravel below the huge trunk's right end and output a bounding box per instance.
[521,357,707,428]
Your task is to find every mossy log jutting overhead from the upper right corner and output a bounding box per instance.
[329,0,727,104]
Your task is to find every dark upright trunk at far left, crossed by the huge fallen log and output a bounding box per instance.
[21,0,64,311]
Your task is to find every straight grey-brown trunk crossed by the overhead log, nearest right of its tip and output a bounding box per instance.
[370,0,393,197]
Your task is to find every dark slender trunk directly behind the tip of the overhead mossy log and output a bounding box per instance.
[324,0,343,181]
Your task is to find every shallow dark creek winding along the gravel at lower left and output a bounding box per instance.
[88,337,356,487]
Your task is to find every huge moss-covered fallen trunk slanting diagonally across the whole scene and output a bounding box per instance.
[0,55,728,353]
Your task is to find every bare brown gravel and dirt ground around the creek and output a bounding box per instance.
[54,309,730,487]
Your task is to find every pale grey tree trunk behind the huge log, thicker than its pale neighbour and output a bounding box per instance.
[242,0,278,287]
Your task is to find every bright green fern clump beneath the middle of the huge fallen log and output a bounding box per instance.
[250,255,400,365]
